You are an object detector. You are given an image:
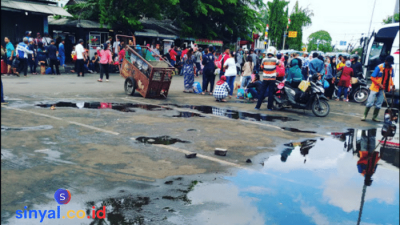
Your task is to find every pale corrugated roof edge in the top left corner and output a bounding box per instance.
[1,0,72,17]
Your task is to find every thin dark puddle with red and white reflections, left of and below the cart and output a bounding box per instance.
[36,102,172,112]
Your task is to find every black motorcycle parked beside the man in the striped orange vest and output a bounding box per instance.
[274,81,330,117]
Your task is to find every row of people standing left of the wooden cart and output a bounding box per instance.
[1,31,125,81]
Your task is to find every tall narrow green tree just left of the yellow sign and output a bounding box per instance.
[267,0,289,48]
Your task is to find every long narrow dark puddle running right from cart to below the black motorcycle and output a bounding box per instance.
[164,104,298,122]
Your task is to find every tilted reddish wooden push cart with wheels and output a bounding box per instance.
[116,35,175,98]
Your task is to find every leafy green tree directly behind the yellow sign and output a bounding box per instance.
[287,1,314,51]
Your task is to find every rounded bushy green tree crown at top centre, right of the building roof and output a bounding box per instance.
[165,0,265,42]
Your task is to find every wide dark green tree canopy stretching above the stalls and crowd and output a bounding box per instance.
[67,0,265,42]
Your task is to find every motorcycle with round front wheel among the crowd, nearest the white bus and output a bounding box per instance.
[333,73,369,103]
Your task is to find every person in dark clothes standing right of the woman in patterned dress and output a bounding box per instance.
[202,47,215,95]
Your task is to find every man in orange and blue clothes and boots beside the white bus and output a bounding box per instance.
[361,55,395,122]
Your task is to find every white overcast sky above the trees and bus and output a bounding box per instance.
[264,0,399,47]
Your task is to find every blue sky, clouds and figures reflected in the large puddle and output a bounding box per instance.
[168,126,399,224]
